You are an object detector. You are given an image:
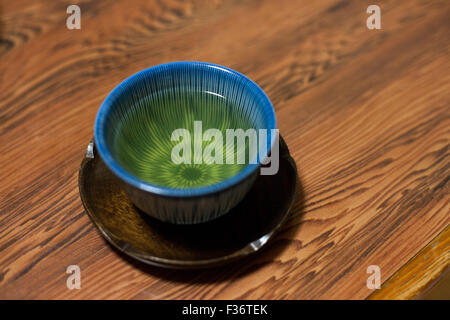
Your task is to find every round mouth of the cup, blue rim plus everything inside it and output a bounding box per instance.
[94,62,276,195]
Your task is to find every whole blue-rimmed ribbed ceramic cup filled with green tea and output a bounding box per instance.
[94,62,278,224]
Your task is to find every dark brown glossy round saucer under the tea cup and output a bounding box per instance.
[78,137,297,269]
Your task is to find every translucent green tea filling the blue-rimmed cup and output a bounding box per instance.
[113,91,253,189]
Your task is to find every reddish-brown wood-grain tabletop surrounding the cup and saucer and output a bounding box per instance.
[0,0,450,299]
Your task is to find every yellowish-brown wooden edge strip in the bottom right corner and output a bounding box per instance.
[368,226,450,300]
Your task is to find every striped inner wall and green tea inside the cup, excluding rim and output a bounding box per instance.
[102,64,265,189]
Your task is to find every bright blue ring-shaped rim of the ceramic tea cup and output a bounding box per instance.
[94,61,277,197]
